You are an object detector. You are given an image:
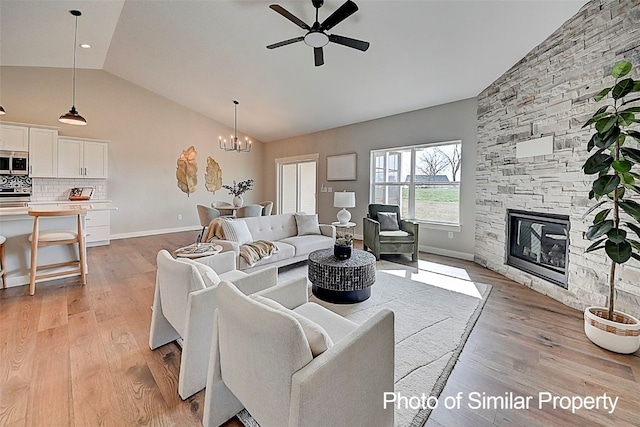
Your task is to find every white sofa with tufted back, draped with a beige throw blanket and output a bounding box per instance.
[209,214,336,272]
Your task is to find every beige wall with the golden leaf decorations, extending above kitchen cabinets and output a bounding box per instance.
[0,67,264,235]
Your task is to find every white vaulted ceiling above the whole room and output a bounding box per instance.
[0,0,586,142]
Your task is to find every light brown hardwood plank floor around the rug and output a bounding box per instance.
[0,232,640,427]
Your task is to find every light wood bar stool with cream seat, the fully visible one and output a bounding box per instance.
[29,209,87,295]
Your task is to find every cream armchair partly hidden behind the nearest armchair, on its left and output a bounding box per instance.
[149,250,278,399]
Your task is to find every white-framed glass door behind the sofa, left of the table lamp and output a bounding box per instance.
[278,159,317,214]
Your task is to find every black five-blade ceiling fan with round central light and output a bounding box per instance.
[267,0,369,67]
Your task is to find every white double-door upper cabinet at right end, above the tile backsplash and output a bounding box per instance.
[58,137,109,179]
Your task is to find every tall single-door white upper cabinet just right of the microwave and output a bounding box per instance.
[29,128,58,178]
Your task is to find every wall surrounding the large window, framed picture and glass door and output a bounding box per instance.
[263,98,477,259]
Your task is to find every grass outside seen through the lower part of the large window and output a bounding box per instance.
[402,184,460,224]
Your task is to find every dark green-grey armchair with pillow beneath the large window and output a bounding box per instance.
[363,204,418,262]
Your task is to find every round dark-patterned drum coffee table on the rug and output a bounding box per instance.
[308,249,376,304]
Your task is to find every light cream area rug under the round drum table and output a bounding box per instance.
[238,260,491,427]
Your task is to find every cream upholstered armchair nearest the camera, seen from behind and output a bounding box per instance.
[203,278,394,427]
